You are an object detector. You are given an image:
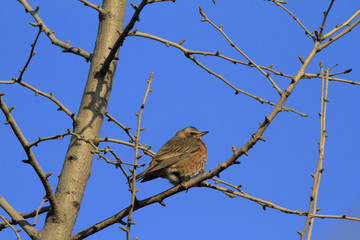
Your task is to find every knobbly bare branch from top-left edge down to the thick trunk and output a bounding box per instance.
[18,0,91,61]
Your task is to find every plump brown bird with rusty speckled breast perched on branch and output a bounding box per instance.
[136,127,208,185]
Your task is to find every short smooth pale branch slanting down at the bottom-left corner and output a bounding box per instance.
[0,196,39,239]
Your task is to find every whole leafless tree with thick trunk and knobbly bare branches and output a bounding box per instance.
[0,0,360,240]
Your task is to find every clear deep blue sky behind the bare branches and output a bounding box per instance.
[0,0,360,240]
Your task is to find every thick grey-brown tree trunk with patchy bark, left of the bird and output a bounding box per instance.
[40,0,127,240]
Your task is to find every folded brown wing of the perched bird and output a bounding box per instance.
[146,138,200,174]
